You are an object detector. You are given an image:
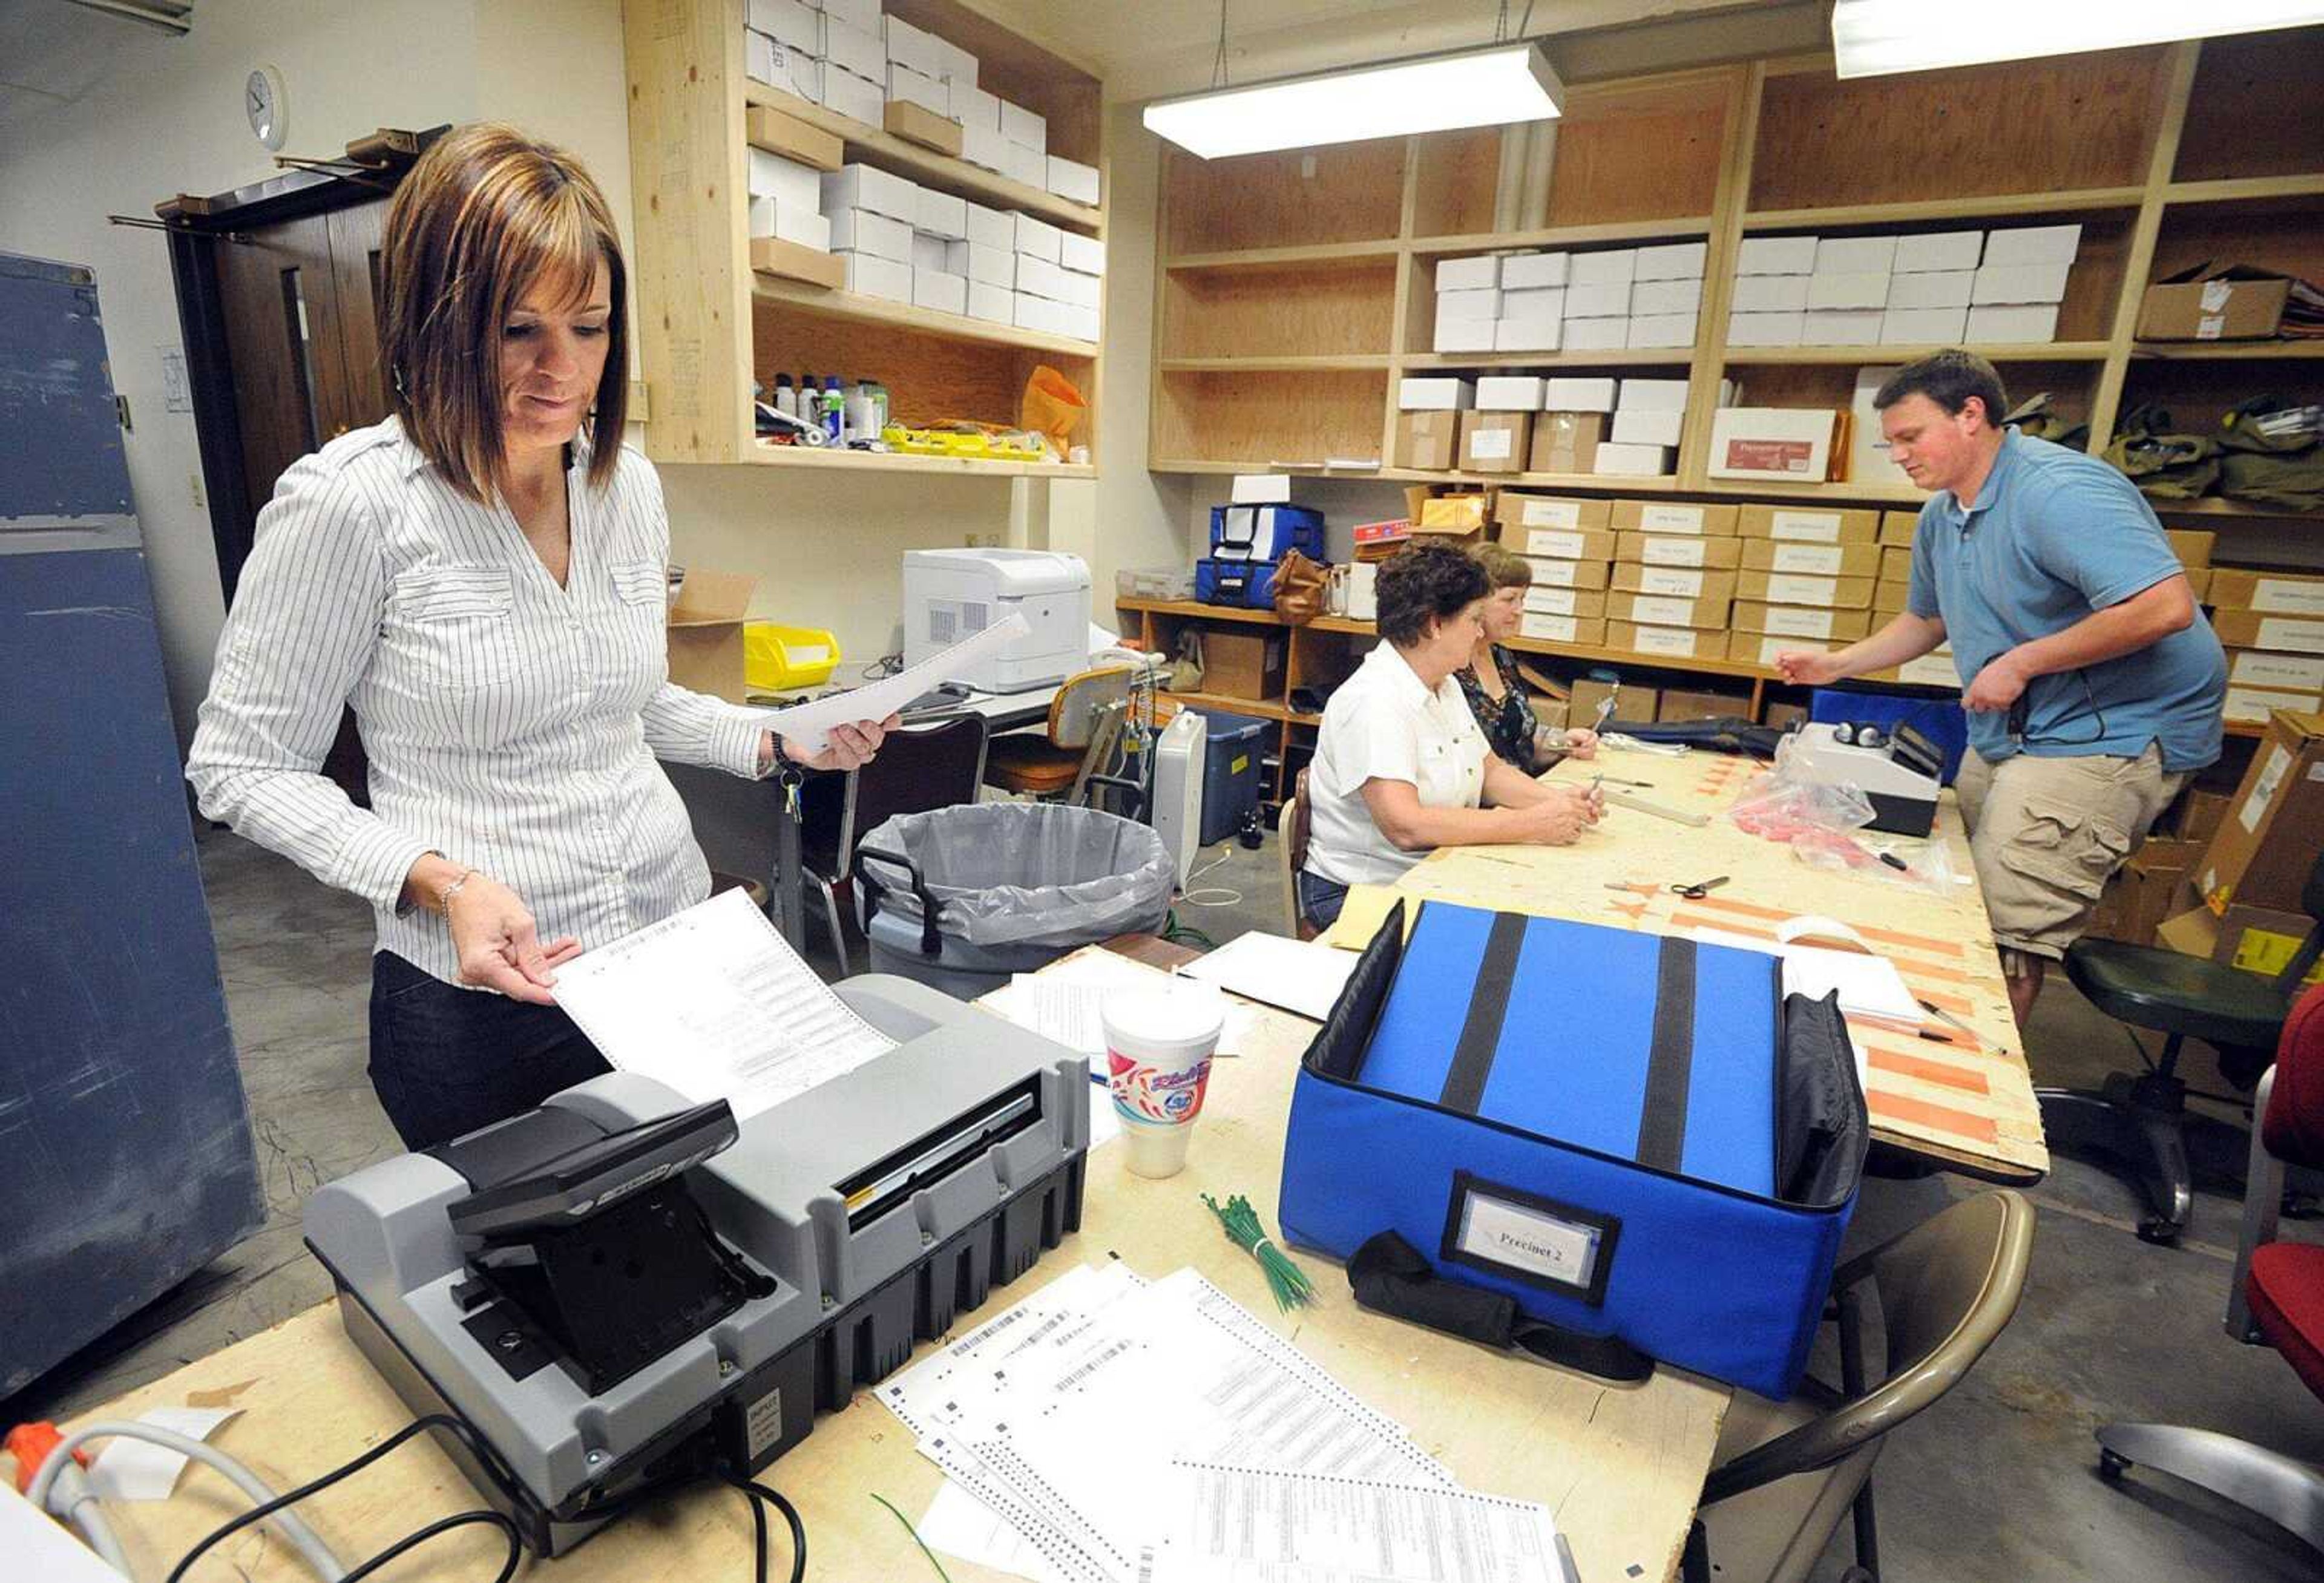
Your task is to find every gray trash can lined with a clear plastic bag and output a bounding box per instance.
[855,802,1176,1000]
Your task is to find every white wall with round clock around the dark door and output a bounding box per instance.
[0,0,476,741]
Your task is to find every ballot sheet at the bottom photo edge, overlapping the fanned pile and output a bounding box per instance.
[1139,1458,1564,1583]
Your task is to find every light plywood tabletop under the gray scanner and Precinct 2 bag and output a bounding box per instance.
[64,953,1727,1583]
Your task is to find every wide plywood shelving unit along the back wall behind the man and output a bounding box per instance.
[1147,28,2324,746]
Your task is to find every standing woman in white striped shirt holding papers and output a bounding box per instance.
[186,123,894,1149]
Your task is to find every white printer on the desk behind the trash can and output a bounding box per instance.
[904,549,1090,693]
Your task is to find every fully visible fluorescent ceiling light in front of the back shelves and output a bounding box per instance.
[1146,44,1564,160]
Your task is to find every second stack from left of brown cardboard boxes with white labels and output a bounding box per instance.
[1606,500,1743,660]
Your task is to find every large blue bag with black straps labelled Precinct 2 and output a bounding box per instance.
[1278,902,1871,1397]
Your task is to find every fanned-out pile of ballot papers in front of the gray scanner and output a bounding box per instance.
[876,1265,1455,1583]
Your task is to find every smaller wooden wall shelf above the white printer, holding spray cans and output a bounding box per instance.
[623,0,1111,479]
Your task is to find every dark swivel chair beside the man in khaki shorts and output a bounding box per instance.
[2034,853,2324,1244]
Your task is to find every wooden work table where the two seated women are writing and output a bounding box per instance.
[1350,749,2050,1185]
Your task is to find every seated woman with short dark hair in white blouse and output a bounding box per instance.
[1297,544,1601,925]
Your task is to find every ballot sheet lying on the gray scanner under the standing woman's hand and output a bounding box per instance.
[556,890,894,1121]
